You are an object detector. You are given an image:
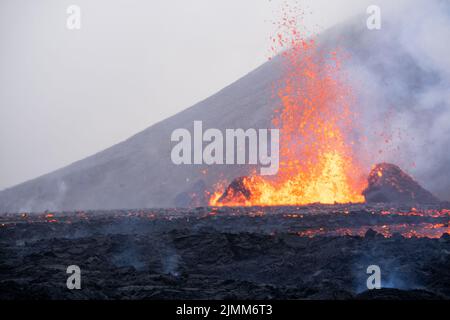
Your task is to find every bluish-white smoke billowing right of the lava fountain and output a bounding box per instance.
[338,0,450,200]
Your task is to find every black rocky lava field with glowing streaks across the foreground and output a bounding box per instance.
[0,205,450,299]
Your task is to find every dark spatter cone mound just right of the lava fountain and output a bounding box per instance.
[363,163,439,204]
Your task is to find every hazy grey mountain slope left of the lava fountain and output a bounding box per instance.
[0,57,278,212]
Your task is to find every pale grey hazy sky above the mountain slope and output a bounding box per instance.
[0,0,396,189]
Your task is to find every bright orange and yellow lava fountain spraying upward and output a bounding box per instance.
[209,13,366,206]
